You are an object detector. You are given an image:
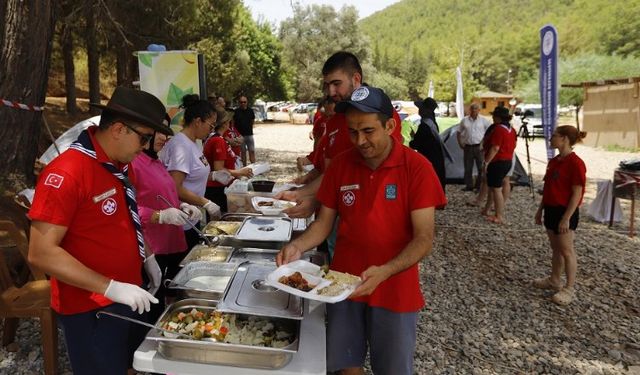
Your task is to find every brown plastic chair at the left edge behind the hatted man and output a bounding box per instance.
[0,220,58,375]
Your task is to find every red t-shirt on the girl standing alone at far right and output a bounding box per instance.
[542,152,587,207]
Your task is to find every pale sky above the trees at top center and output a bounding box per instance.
[244,0,399,27]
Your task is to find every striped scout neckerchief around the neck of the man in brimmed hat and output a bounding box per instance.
[69,130,146,259]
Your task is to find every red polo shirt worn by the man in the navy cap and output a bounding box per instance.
[317,140,447,312]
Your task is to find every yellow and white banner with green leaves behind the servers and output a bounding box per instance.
[138,51,200,130]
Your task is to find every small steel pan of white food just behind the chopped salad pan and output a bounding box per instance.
[167,262,238,301]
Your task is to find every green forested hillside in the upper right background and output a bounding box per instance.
[360,0,640,100]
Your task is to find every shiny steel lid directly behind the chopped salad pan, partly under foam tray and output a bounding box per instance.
[218,262,303,319]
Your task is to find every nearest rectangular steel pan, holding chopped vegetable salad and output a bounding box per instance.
[147,299,300,370]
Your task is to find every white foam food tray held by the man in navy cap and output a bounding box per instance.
[265,260,358,303]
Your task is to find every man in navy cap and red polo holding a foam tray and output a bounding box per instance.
[276,86,446,375]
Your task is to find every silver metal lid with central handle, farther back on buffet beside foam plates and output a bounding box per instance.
[236,216,293,242]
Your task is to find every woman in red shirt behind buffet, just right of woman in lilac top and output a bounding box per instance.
[202,107,253,212]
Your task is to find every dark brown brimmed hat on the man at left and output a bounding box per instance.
[89,86,173,135]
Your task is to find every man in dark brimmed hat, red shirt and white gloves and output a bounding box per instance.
[28,87,172,374]
